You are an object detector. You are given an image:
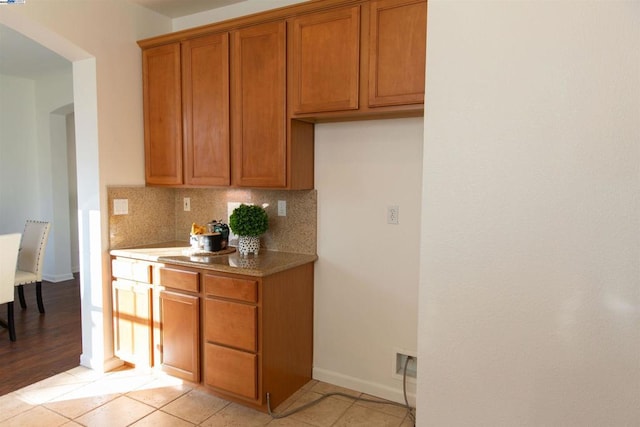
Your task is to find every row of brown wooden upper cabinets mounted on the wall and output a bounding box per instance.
[138,0,427,190]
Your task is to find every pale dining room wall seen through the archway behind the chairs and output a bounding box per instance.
[0,70,73,282]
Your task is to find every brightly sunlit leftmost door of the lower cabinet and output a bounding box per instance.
[112,279,153,366]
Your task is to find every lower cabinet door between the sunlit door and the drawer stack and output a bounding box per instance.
[160,291,200,382]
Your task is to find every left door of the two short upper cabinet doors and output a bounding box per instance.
[289,6,360,114]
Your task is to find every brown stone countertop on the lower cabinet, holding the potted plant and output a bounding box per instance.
[110,241,318,277]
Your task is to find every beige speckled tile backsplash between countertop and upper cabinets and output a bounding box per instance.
[108,187,317,254]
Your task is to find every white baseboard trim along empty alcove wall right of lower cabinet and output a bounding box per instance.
[313,368,416,407]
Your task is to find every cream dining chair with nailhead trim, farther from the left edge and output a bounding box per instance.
[15,220,51,313]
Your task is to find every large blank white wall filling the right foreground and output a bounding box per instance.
[418,0,640,426]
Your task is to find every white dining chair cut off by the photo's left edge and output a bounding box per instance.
[0,233,20,341]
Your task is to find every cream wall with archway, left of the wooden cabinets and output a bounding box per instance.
[0,0,171,370]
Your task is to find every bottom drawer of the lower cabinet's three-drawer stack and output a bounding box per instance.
[204,344,258,399]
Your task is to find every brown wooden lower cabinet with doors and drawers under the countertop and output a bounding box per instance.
[112,257,313,411]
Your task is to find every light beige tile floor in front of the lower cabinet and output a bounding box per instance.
[0,367,413,427]
